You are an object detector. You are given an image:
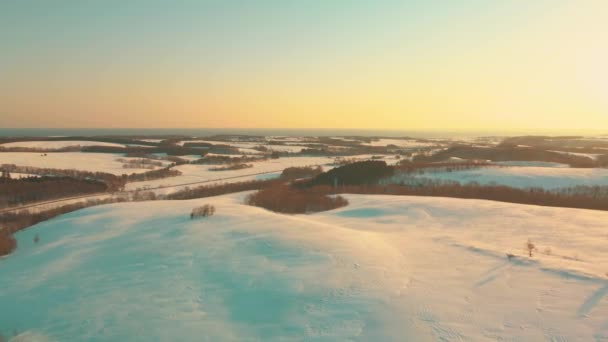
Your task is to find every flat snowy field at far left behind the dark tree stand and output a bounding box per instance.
[0,152,168,175]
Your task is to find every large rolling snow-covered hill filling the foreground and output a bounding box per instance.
[0,194,608,341]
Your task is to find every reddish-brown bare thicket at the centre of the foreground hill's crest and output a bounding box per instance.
[245,183,348,214]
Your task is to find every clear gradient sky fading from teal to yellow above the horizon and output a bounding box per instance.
[0,0,608,130]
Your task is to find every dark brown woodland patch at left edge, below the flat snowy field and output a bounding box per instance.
[0,177,108,208]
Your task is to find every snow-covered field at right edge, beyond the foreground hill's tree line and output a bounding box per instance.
[387,166,608,189]
